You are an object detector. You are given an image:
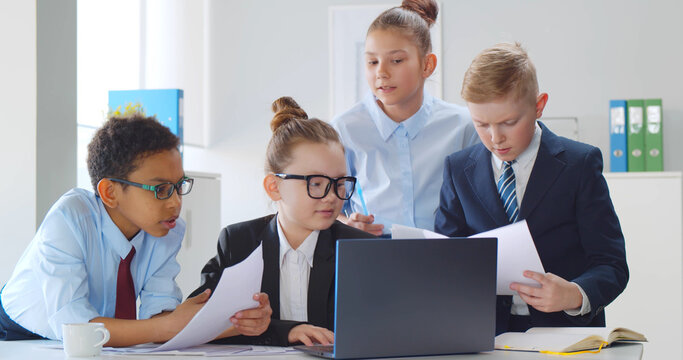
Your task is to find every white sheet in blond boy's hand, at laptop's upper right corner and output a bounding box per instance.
[470,220,545,295]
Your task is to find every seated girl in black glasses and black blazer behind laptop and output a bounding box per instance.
[194,97,372,346]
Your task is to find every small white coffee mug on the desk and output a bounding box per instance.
[62,323,109,357]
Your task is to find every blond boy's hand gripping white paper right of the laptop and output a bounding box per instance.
[510,270,583,313]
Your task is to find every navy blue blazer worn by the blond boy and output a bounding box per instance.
[435,122,629,333]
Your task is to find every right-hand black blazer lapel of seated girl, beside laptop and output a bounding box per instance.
[308,229,335,325]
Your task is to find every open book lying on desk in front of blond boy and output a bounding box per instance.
[495,327,647,353]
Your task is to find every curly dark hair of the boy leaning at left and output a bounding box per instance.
[87,114,180,194]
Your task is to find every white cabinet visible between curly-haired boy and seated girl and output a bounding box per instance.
[176,172,221,298]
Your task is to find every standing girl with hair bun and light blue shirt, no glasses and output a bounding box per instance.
[332,0,479,236]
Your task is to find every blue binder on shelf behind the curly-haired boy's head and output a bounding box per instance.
[109,89,183,146]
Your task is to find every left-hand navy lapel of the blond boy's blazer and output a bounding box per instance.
[464,145,509,226]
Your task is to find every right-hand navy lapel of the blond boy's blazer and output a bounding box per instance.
[519,122,567,220]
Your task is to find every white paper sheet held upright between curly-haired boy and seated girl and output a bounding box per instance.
[145,245,263,352]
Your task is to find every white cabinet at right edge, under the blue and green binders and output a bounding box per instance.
[605,172,683,359]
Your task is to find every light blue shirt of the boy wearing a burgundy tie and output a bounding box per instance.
[0,189,185,340]
